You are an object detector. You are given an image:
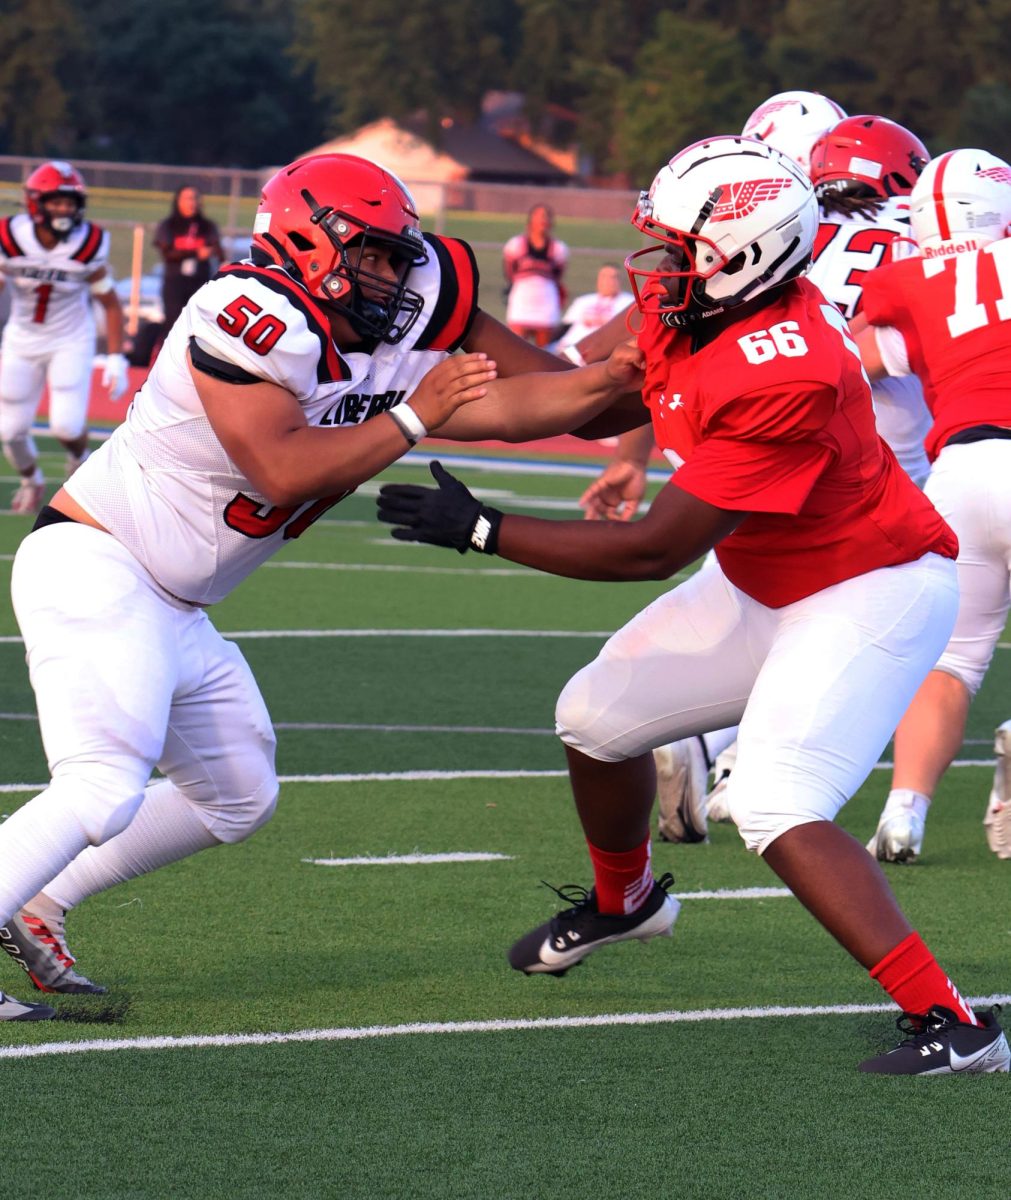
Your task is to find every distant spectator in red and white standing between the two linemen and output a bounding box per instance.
[502,204,569,346]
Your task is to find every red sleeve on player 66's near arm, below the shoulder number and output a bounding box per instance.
[674,382,837,512]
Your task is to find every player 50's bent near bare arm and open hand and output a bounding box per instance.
[191,354,495,506]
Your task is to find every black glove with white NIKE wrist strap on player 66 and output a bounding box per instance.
[376,462,502,554]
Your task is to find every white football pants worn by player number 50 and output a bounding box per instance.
[7,522,277,883]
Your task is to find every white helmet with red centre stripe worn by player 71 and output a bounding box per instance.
[909,150,1011,258]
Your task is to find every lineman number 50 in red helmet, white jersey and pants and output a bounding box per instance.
[0,155,642,1020]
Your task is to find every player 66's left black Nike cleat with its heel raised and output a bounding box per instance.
[509,872,681,976]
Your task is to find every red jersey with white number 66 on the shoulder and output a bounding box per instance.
[639,280,958,608]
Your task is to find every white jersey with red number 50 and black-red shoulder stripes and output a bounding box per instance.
[66,235,477,605]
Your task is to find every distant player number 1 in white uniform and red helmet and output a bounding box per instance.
[0,162,126,512]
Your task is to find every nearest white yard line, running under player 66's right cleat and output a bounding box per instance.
[0,995,1011,1058]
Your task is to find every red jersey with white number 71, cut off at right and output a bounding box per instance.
[863,239,1011,460]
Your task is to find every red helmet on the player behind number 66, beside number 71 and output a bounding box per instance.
[810,115,931,198]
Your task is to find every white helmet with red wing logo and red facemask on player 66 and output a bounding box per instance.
[626,137,819,326]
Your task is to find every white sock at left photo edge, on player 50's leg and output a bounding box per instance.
[0,788,88,925]
